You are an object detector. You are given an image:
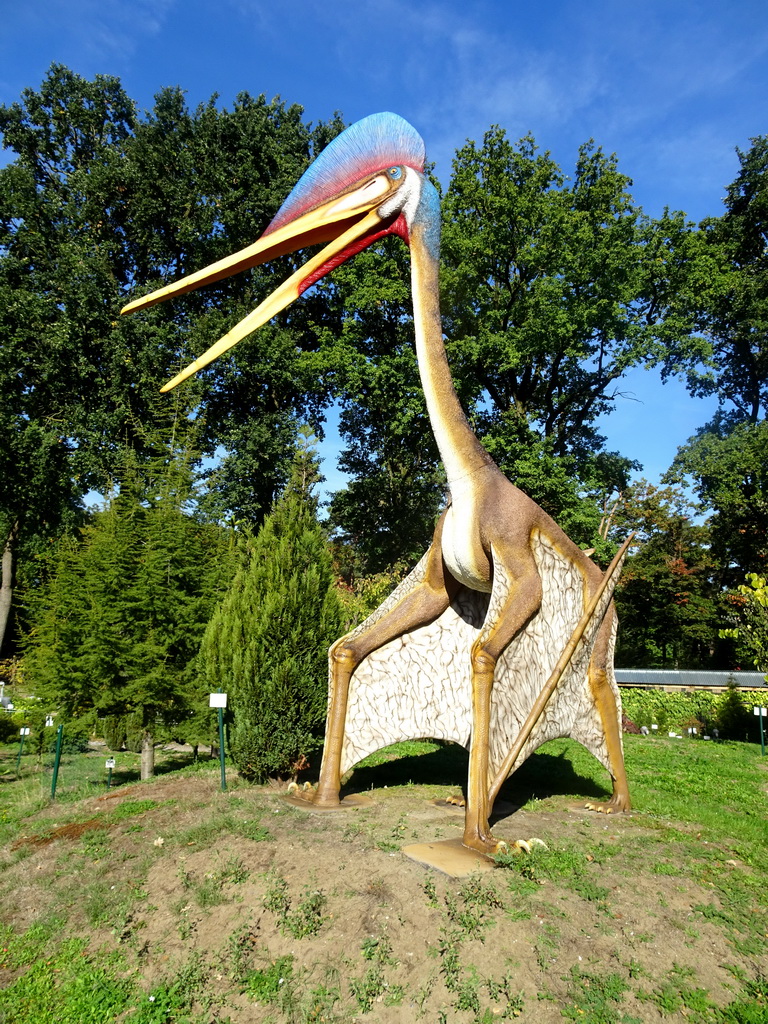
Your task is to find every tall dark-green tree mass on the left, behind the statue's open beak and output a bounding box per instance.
[0,65,339,642]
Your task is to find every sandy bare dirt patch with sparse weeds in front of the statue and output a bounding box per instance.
[0,757,768,1024]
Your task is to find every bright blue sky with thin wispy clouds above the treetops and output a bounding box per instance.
[0,0,768,495]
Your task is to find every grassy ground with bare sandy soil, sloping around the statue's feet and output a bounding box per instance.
[0,735,768,1024]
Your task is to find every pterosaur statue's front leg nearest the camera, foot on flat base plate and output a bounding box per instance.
[463,546,542,854]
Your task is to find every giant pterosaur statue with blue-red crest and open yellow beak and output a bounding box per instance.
[123,113,630,854]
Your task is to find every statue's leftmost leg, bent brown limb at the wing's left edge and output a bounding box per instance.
[312,522,456,807]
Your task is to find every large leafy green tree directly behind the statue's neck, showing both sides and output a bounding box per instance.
[331,128,692,571]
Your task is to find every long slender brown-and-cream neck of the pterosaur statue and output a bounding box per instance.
[410,226,493,490]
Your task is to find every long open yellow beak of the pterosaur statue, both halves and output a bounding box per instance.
[121,176,387,391]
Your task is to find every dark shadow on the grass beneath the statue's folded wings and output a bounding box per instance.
[343,743,610,817]
